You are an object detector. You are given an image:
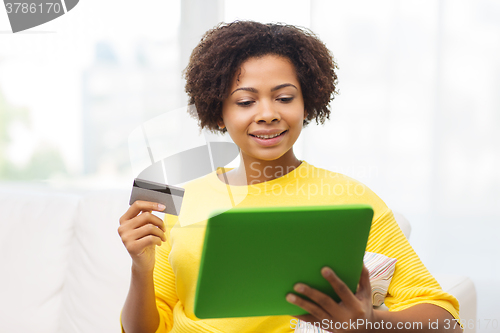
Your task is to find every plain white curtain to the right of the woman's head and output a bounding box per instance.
[304,0,500,326]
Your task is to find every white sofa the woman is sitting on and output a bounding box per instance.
[0,185,476,333]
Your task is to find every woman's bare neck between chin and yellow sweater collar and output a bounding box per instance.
[230,147,301,185]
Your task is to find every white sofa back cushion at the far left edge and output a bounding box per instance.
[0,186,79,333]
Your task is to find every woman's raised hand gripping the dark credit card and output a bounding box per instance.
[118,200,166,271]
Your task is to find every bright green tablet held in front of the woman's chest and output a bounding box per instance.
[194,204,373,319]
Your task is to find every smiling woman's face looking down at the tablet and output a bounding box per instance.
[219,55,307,161]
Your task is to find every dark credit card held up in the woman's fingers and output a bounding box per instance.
[129,178,184,216]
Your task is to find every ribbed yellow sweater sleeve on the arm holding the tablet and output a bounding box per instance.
[367,209,459,319]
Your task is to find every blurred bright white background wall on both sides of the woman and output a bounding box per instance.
[0,0,500,332]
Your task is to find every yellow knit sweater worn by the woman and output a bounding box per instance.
[120,161,458,333]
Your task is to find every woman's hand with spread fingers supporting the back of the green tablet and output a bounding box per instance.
[286,265,375,332]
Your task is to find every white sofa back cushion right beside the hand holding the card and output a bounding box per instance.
[59,190,132,333]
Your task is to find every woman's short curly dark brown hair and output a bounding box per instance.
[184,21,338,133]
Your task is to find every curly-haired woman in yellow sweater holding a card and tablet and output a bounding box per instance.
[118,21,460,333]
